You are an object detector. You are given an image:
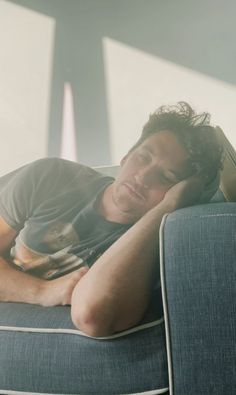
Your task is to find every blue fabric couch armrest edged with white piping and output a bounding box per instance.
[160,203,236,395]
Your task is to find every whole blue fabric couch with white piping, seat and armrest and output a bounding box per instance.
[0,168,236,395]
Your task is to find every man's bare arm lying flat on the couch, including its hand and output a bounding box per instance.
[0,218,87,306]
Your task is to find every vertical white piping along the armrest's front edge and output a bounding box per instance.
[159,214,174,395]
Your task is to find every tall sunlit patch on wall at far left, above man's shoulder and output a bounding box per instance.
[0,0,55,175]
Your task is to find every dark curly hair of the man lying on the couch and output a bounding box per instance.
[130,101,223,180]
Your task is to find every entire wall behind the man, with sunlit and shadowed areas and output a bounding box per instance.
[0,0,236,175]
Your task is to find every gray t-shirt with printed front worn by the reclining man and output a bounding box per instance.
[0,158,130,279]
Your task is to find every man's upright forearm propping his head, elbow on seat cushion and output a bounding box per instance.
[72,203,173,336]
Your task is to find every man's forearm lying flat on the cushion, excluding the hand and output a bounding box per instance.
[0,257,44,304]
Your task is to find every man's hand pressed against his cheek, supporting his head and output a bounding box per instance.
[163,175,205,210]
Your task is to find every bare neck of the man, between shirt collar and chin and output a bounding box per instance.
[96,184,137,224]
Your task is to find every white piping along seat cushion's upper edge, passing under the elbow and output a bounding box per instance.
[0,317,164,340]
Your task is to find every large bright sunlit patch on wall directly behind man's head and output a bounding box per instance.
[103,38,236,164]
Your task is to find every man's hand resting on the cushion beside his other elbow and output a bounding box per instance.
[40,267,89,306]
